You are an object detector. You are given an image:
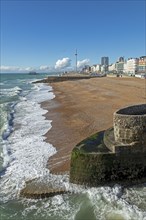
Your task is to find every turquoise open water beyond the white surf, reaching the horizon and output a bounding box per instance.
[0,74,50,170]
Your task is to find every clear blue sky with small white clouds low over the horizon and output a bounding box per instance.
[0,0,146,72]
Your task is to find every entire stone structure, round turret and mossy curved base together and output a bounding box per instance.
[70,104,146,186]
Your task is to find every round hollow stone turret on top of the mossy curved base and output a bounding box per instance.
[113,104,146,145]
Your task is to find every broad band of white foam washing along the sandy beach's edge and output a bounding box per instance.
[0,84,56,200]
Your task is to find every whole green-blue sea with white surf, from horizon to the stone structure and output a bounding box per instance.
[0,74,146,220]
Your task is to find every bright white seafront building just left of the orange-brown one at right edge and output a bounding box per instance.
[127,58,138,75]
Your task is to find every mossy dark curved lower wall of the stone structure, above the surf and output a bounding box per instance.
[70,136,146,186]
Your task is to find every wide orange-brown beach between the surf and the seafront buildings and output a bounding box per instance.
[42,77,146,174]
